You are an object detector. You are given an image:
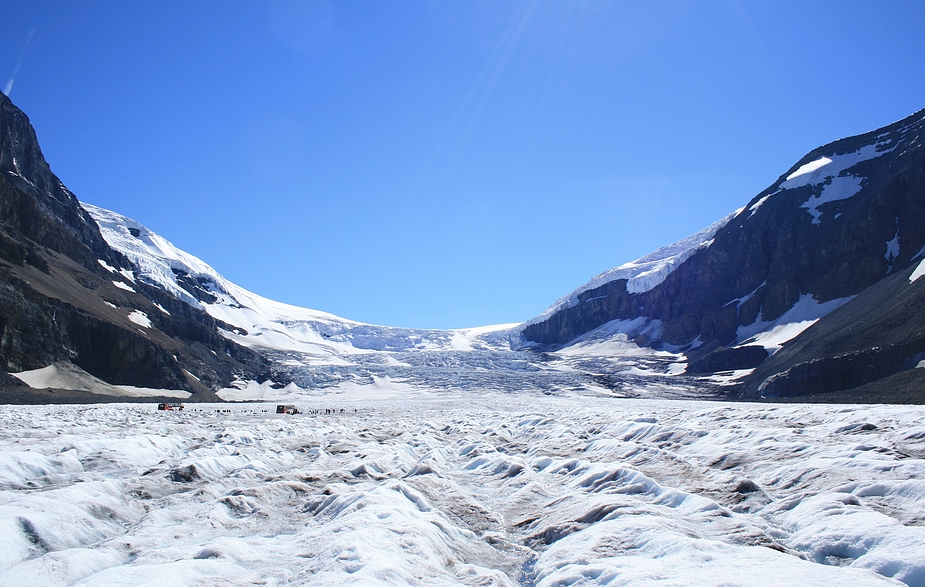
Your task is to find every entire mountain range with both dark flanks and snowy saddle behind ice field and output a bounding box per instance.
[0,86,925,402]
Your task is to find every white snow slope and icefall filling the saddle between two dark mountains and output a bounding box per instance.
[84,204,715,401]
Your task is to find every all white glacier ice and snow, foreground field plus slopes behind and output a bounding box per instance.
[0,205,925,587]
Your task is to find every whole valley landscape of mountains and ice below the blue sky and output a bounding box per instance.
[0,87,925,587]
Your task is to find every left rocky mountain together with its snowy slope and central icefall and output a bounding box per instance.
[0,97,692,402]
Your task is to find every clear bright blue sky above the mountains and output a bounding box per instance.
[0,0,925,328]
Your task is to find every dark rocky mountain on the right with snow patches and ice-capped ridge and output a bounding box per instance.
[514,111,925,401]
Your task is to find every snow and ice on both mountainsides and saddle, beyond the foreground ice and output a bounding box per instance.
[74,200,879,401]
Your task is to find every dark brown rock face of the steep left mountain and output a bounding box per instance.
[0,94,269,400]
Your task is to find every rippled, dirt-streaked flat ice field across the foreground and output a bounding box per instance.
[0,394,925,587]
